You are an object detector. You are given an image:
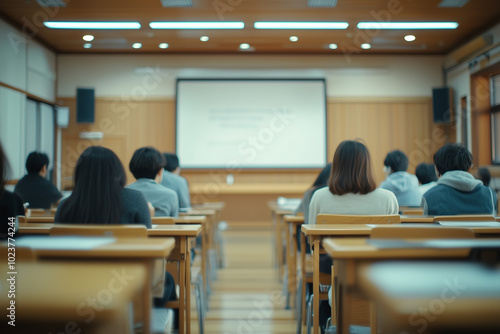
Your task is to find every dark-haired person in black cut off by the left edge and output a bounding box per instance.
[0,143,24,239]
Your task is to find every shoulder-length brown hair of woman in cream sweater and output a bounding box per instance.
[329,140,377,195]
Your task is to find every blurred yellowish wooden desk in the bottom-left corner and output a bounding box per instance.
[0,261,149,333]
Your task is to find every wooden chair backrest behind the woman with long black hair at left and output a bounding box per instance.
[49,224,148,238]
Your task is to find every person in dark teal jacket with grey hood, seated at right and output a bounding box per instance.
[422,144,497,216]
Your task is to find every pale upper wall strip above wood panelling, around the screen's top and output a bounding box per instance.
[57,54,443,99]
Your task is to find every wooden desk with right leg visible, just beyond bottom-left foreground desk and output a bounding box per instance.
[17,236,175,333]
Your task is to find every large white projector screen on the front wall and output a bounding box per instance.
[176,79,326,170]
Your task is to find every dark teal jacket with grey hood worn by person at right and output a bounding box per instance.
[422,170,497,216]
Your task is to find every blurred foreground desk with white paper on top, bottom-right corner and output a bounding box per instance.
[356,261,500,333]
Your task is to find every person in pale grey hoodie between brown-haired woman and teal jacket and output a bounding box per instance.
[380,150,422,206]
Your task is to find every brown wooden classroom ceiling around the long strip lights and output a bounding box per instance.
[0,0,500,55]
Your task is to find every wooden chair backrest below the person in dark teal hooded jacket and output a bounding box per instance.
[370,224,475,239]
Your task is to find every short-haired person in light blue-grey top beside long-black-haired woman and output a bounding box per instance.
[127,147,179,217]
